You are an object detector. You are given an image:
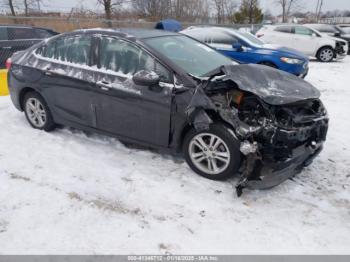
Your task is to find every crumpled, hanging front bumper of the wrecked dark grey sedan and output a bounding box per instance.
[236,118,328,196]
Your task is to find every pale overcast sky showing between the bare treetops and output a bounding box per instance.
[45,0,350,14]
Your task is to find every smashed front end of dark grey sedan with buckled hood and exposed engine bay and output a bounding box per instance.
[187,65,329,196]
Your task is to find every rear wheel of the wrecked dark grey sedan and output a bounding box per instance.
[23,92,55,132]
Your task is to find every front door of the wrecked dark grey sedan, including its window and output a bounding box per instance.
[93,37,173,146]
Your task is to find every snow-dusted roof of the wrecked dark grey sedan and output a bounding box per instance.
[74,28,181,39]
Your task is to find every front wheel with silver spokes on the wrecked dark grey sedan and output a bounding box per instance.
[183,123,241,180]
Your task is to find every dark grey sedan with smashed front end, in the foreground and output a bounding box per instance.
[8,29,328,195]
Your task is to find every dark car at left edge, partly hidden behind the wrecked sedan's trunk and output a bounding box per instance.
[0,25,58,69]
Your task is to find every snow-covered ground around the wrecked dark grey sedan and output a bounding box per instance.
[0,57,350,254]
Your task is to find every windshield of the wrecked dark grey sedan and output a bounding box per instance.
[144,36,236,77]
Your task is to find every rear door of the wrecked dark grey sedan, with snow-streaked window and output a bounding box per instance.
[34,35,96,127]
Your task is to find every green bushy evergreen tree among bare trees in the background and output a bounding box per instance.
[233,0,264,24]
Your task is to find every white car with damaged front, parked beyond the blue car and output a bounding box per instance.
[256,24,349,62]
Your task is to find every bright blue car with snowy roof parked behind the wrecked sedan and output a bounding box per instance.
[181,27,309,78]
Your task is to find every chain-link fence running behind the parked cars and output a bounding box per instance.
[0,16,261,69]
